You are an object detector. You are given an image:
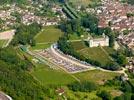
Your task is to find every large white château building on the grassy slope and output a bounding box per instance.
[88,35,109,47]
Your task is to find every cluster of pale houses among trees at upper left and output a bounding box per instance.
[0,4,66,30]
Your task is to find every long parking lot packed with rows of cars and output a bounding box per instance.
[38,49,89,73]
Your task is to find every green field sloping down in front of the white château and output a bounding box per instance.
[71,41,114,65]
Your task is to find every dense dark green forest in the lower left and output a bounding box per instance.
[0,47,47,100]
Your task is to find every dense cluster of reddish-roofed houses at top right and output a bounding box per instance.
[96,0,134,32]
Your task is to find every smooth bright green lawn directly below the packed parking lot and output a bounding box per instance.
[31,65,75,85]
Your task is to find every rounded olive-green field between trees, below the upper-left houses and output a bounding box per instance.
[35,26,63,43]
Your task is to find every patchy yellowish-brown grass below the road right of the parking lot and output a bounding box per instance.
[74,70,120,85]
